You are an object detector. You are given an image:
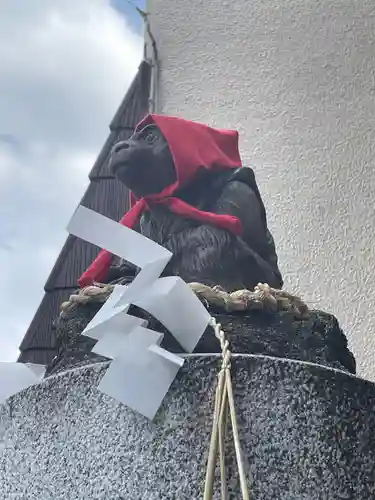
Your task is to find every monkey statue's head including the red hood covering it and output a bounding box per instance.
[110,114,241,198]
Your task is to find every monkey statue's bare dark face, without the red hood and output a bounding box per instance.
[109,124,176,198]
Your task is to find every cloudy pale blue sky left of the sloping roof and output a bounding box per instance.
[0,0,144,361]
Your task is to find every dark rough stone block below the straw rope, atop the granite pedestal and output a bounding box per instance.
[49,296,355,374]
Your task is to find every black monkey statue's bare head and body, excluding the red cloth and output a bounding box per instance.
[106,125,282,292]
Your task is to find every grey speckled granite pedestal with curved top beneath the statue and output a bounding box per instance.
[0,355,375,500]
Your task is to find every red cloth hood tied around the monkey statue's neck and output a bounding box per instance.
[78,114,243,287]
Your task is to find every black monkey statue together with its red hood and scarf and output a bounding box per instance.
[80,116,282,292]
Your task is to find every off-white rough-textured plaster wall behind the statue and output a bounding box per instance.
[149,0,375,379]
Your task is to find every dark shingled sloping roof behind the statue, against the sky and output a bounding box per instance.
[18,61,151,364]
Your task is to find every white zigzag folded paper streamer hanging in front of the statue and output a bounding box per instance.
[68,206,210,419]
